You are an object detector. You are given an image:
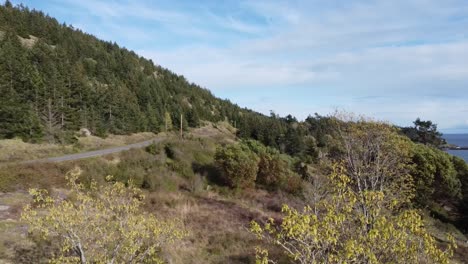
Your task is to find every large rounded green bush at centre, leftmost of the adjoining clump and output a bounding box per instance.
[215,144,258,188]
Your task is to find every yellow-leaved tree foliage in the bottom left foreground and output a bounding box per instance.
[22,169,185,263]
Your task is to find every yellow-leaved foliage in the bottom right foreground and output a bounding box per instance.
[251,168,455,264]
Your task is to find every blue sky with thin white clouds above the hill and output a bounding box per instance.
[12,0,468,133]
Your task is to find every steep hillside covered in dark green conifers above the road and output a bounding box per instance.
[0,2,256,141]
